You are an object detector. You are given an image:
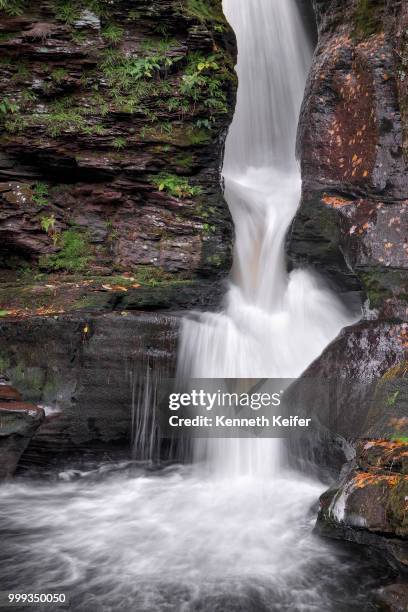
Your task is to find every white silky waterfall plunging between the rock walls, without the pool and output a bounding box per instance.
[179,0,352,478]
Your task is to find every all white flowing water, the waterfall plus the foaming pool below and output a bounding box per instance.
[0,0,392,612]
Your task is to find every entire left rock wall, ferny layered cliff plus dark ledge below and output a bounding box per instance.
[0,0,237,466]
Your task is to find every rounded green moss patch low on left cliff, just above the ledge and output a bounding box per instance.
[39,229,92,272]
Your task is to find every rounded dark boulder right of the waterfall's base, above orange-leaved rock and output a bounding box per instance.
[289,320,408,478]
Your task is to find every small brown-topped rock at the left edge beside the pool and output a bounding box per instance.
[0,385,44,480]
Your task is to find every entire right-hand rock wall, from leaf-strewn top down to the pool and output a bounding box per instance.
[288,0,408,565]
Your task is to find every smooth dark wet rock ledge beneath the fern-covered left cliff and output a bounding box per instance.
[0,312,179,468]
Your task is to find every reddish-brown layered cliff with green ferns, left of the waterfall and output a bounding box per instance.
[0,0,236,314]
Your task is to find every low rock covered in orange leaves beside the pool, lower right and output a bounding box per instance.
[317,440,408,569]
